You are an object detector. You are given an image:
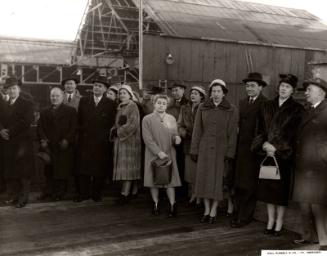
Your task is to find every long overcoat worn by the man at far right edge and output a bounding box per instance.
[293,99,327,206]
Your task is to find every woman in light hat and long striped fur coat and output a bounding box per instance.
[111,85,141,203]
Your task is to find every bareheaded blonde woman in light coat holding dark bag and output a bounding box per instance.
[142,95,181,217]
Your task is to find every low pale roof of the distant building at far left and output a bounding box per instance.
[0,38,76,65]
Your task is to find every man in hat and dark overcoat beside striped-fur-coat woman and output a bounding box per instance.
[75,76,116,202]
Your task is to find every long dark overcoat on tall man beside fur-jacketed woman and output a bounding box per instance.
[235,94,267,191]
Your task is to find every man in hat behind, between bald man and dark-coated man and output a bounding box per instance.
[61,77,82,111]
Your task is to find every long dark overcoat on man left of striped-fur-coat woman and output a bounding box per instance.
[76,95,116,177]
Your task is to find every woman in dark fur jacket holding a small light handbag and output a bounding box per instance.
[253,74,303,236]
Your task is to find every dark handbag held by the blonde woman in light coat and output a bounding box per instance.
[151,157,173,185]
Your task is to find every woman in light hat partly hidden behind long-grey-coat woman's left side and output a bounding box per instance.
[178,86,206,204]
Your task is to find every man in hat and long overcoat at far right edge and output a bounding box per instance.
[293,78,327,250]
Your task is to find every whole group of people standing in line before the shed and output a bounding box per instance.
[0,72,327,248]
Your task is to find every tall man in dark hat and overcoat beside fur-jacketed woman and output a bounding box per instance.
[231,72,267,228]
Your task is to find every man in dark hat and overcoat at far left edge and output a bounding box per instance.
[0,76,35,208]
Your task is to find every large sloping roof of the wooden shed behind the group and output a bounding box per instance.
[138,0,327,49]
